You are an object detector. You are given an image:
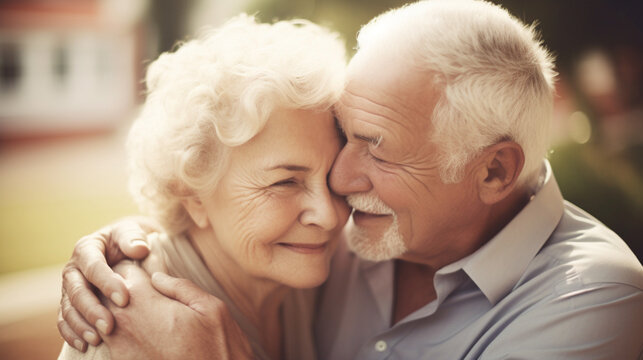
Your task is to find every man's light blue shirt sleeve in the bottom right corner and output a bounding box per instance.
[480,283,643,360]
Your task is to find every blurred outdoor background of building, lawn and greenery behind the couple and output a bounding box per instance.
[0,0,643,359]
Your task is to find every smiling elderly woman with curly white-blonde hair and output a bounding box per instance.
[61,16,348,359]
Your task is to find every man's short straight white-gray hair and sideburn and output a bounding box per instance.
[358,0,556,185]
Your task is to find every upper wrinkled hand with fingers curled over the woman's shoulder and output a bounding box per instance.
[58,218,156,351]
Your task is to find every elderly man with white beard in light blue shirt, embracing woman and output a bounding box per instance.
[59,1,643,359]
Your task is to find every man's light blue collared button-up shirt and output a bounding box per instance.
[315,162,643,360]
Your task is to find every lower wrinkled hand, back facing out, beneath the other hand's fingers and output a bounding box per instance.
[103,262,253,359]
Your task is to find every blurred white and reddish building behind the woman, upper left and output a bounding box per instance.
[0,0,147,140]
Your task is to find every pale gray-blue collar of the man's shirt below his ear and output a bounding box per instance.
[462,160,564,304]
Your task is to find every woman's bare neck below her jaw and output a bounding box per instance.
[188,228,289,359]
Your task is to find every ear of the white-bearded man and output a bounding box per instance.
[477,141,525,205]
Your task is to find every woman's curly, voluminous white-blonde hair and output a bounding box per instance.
[127,15,346,234]
